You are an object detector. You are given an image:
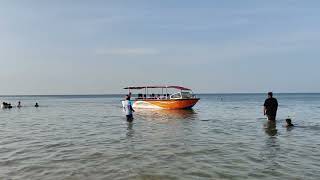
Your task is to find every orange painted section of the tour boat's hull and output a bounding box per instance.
[144,99,199,109]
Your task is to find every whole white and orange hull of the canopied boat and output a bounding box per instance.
[132,98,199,109]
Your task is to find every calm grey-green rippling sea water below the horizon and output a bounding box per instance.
[0,94,320,180]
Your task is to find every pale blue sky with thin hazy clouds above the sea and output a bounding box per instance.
[0,0,320,95]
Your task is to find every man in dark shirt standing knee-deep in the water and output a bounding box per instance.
[263,92,278,121]
